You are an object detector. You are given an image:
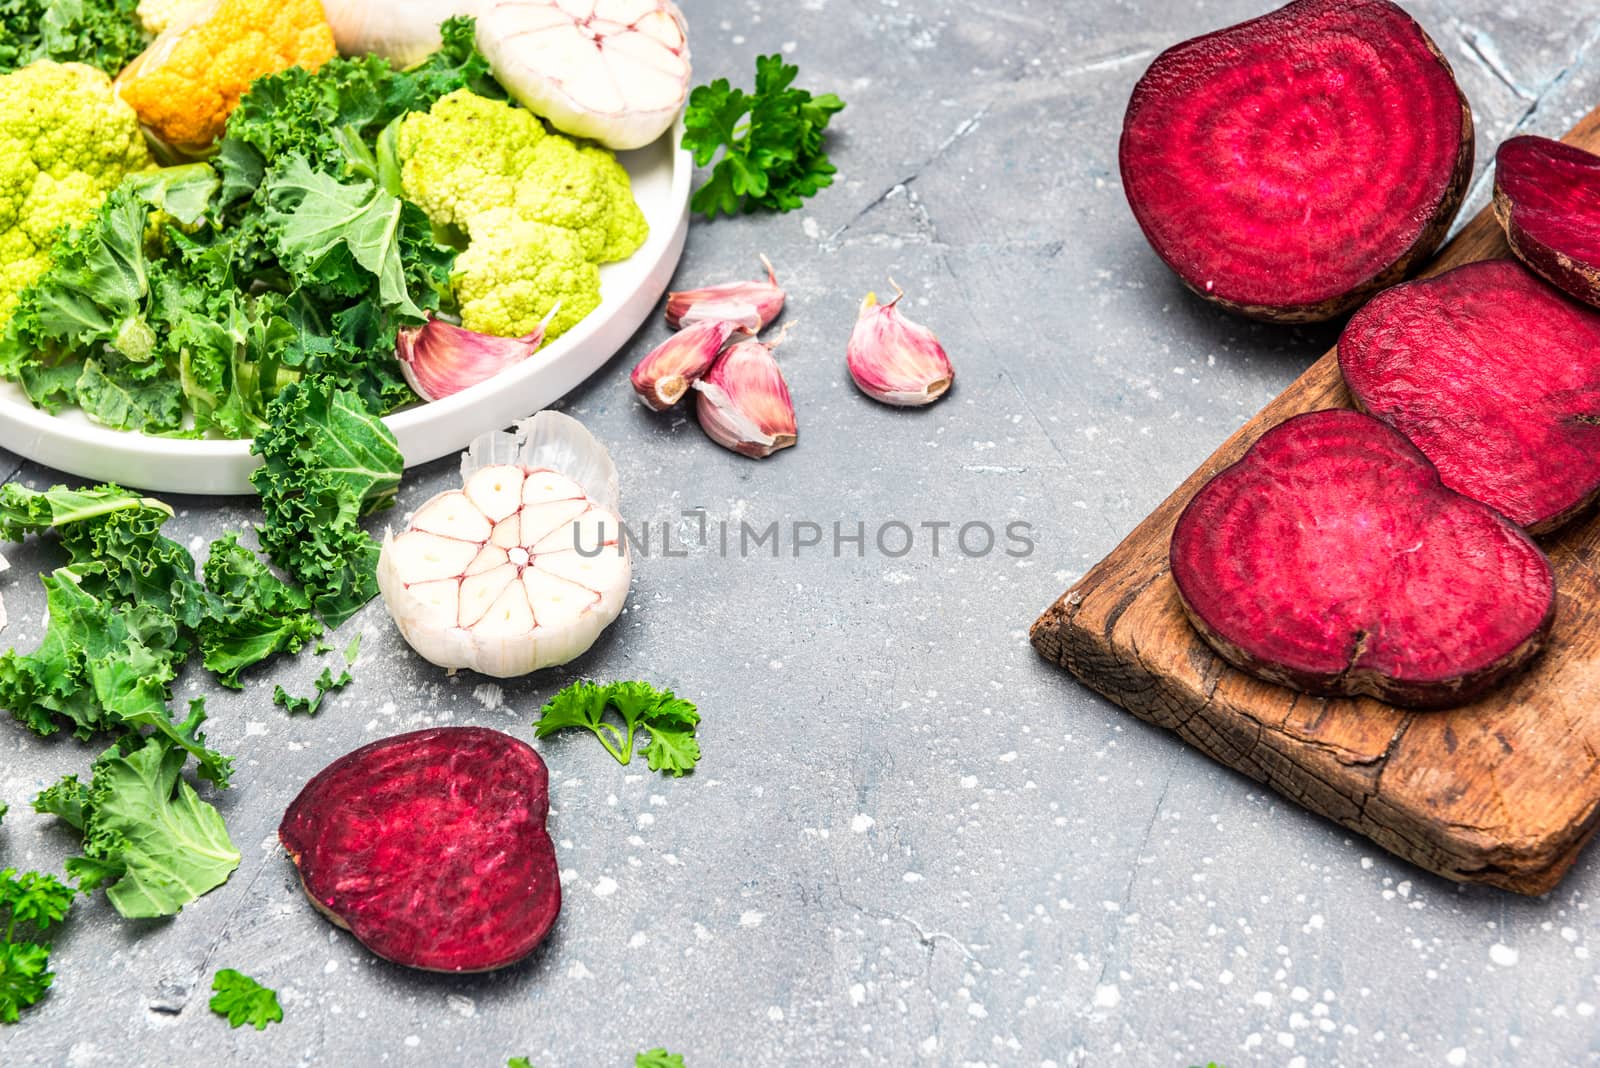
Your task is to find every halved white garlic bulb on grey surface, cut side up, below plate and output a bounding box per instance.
[378,412,632,678]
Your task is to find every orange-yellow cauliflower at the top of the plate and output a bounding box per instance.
[117,0,334,152]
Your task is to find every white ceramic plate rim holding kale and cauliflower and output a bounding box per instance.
[0,128,693,494]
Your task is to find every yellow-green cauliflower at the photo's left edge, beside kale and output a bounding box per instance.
[0,59,154,326]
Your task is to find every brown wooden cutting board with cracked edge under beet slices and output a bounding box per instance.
[1032,109,1600,894]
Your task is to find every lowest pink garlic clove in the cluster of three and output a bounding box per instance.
[694,337,798,459]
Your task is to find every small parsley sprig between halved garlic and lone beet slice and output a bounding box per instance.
[533,683,699,777]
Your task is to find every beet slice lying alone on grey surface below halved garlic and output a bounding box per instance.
[278,727,562,972]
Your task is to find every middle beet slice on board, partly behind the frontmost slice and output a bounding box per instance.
[1339,259,1600,532]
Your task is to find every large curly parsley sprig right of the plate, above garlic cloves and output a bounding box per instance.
[683,54,845,219]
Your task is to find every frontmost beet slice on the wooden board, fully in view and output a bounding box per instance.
[1171,409,1555,707]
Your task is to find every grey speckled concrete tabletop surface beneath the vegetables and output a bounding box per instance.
[0,0,1600,1068]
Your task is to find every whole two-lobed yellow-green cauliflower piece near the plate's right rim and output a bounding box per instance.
[395,90,650,337]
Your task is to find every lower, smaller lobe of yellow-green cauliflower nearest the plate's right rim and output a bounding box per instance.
[451,208,600,337]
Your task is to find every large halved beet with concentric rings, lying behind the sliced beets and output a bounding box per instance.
[1120,0,1472,321]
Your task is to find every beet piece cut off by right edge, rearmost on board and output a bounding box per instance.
[1494,137,1600,307]
